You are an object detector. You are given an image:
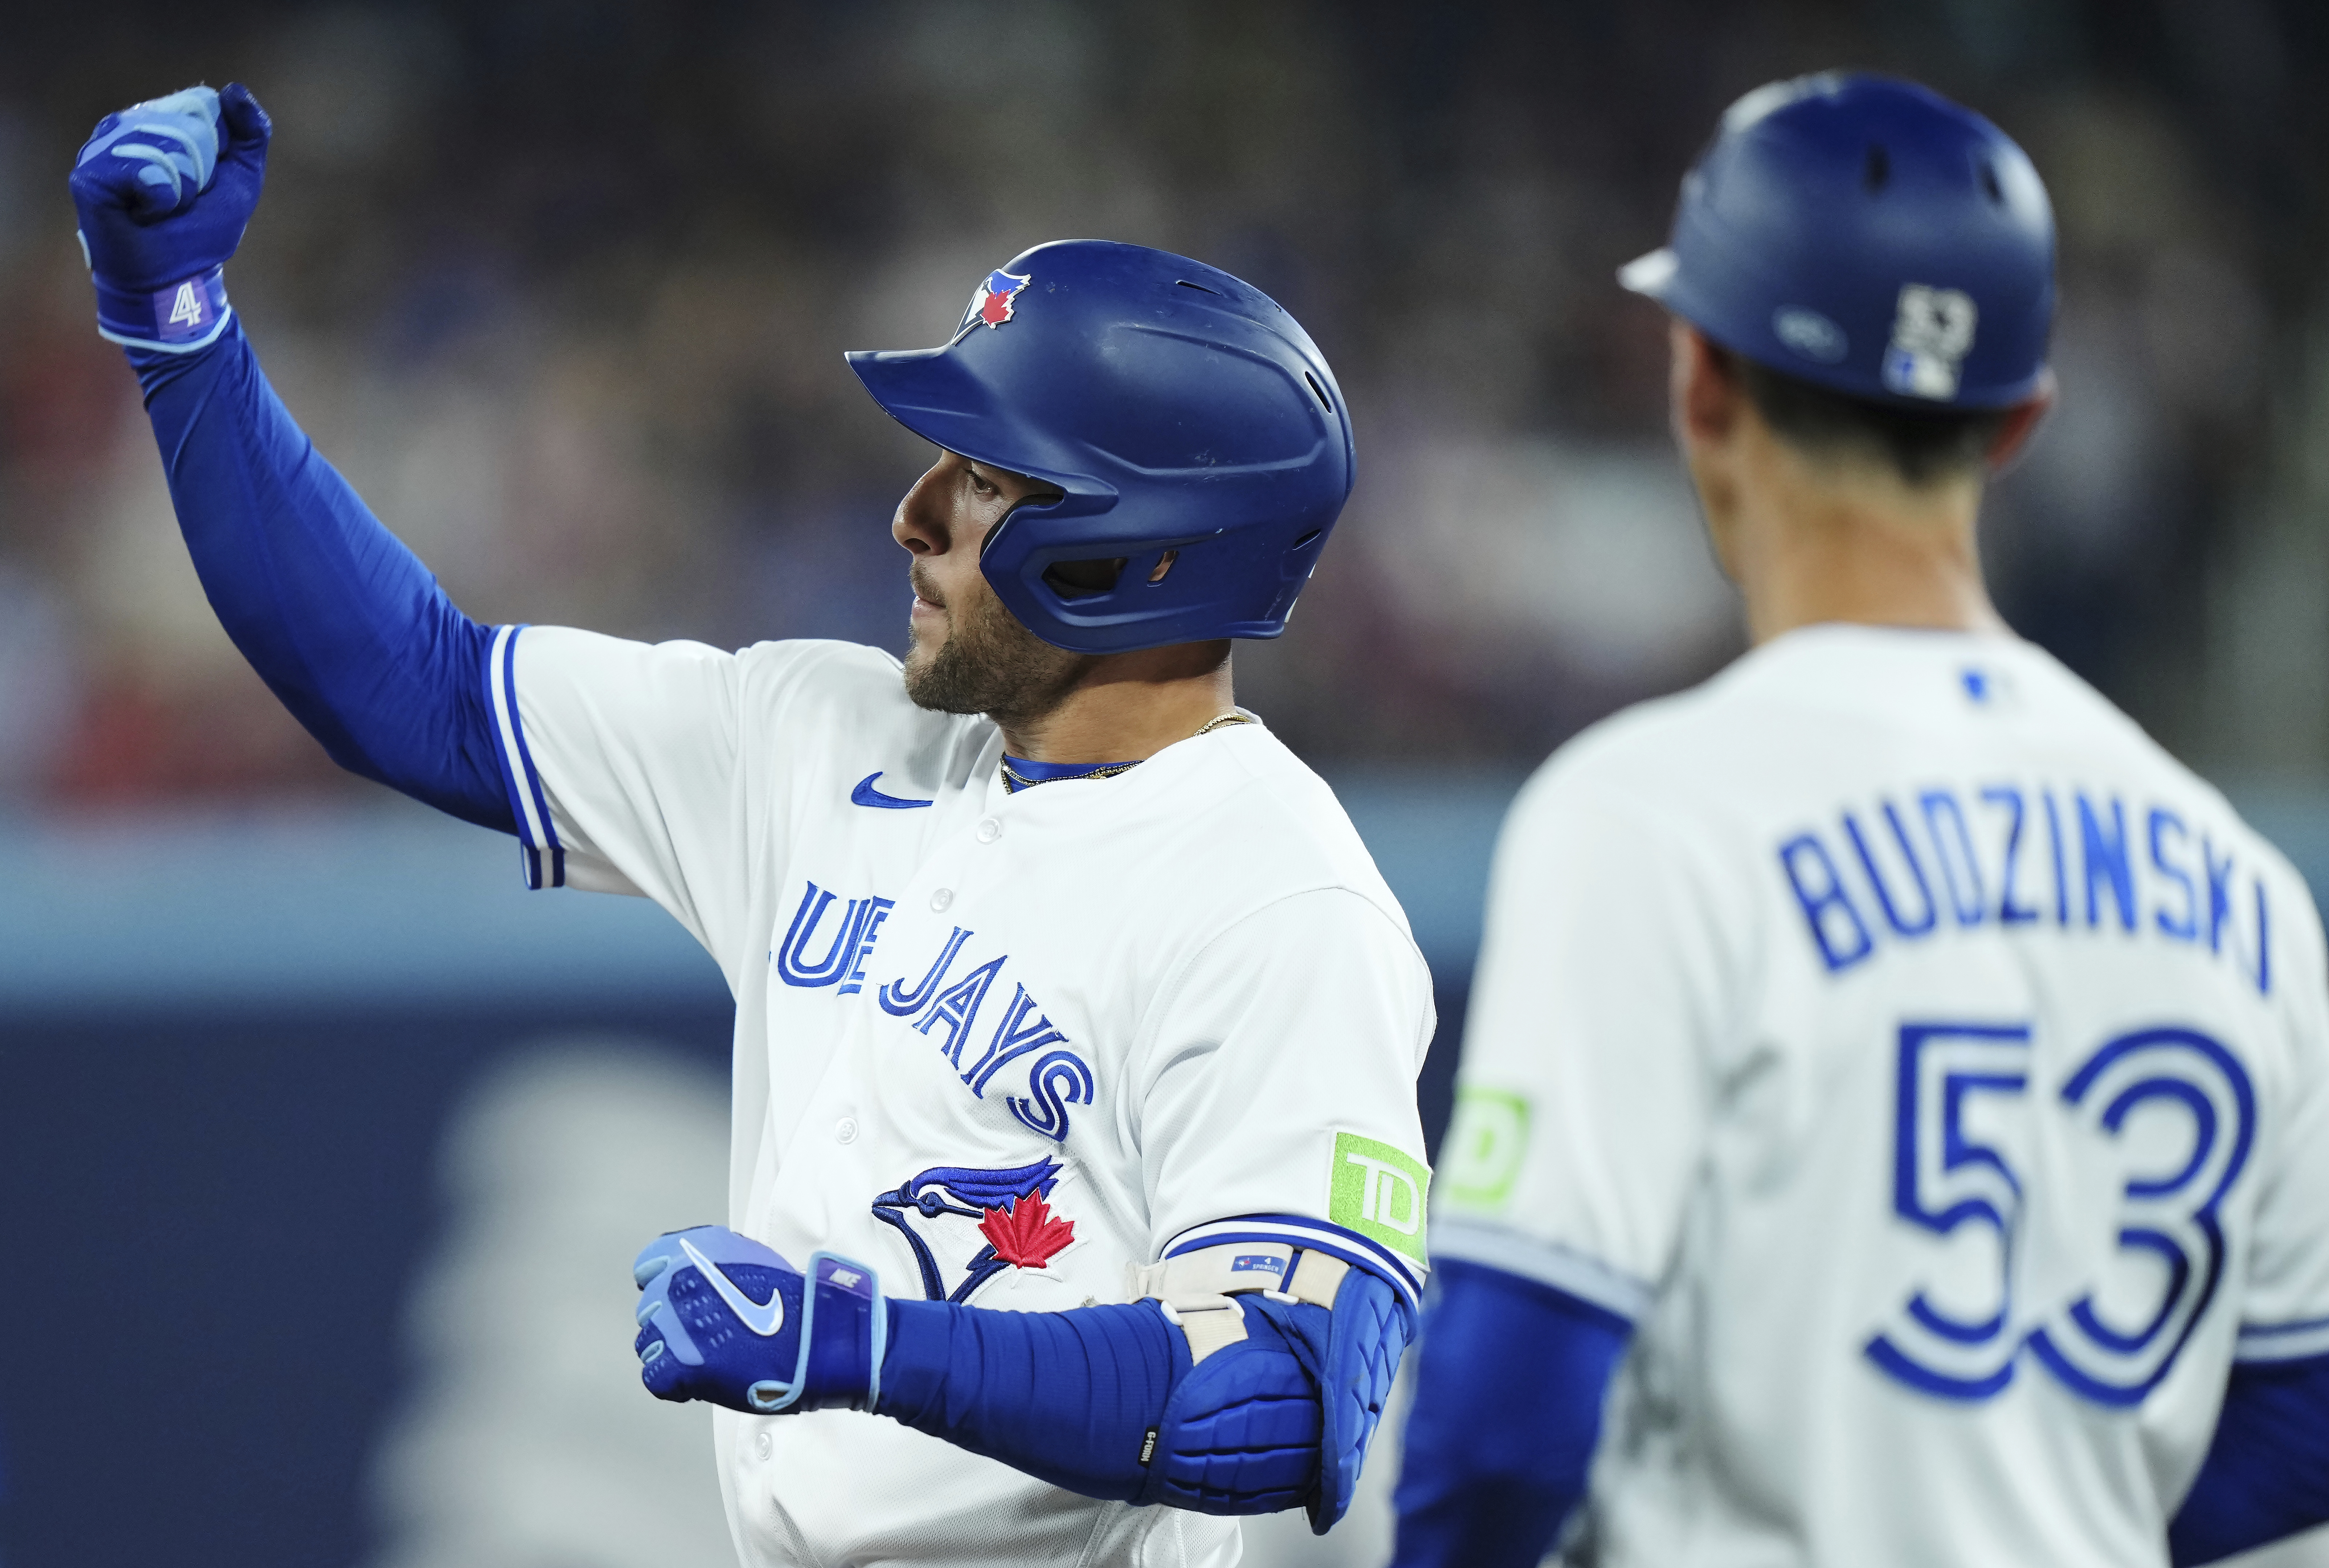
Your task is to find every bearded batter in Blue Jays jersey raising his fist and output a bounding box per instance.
[72,86,1432,1566]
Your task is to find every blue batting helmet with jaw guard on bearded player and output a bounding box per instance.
[850,240,1356,652]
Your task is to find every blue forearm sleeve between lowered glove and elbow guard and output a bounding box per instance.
[880,1300,1188,1503]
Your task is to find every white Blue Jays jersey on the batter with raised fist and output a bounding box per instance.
[491,627,1432,1568]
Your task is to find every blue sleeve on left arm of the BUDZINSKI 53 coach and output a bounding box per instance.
[1393,1258,1633,1568]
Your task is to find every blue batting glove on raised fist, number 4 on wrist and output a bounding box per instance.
[72,82,273,354]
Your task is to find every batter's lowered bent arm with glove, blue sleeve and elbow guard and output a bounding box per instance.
[631,1223,1414,1533]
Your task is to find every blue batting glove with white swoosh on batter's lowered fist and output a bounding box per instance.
[631,1225,890,1417]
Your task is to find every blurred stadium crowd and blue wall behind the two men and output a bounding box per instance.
[0,0,2329,1568]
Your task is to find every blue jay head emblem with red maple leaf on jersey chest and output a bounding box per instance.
[873,1158,1076,1302]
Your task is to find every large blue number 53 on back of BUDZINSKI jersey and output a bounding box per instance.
[1866,1021,2257,1407]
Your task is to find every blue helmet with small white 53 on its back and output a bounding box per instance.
[1619,72,2054,410]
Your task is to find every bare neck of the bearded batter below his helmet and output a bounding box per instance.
[994,638,1237,767]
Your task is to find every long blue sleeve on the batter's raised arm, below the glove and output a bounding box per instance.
[130,317,517,832]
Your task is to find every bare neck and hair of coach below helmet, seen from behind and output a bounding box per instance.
[1672,322,2043,643]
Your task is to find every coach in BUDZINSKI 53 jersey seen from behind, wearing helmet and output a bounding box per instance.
[1397,74,2329,1568]
